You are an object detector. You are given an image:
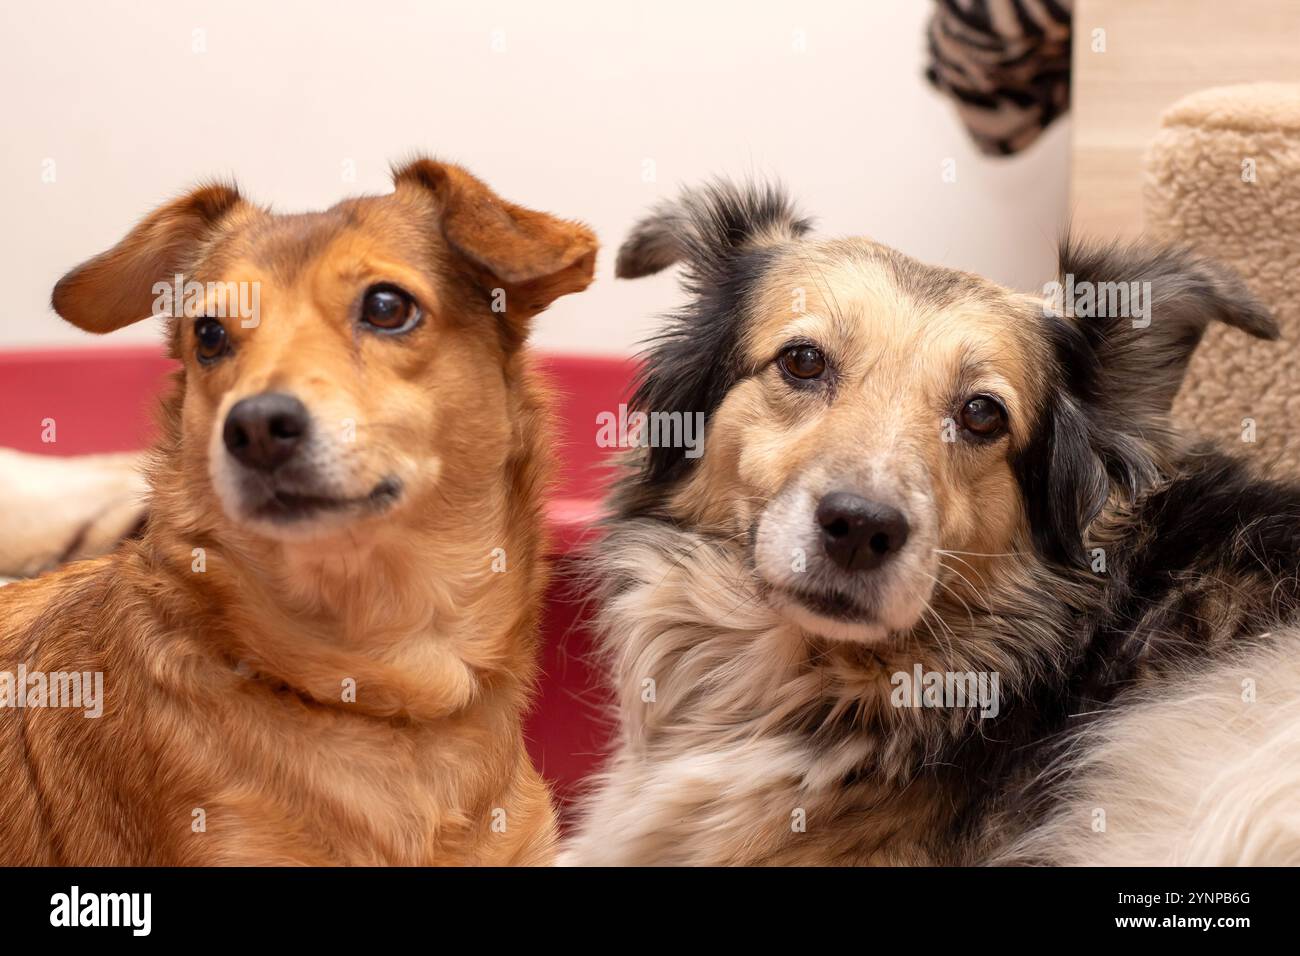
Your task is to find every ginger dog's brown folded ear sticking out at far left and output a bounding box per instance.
[51,183,243,333]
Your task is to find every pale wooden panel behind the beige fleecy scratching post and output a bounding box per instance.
[1070,0,1300,237]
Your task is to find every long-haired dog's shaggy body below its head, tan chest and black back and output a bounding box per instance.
[567,457,1300,865]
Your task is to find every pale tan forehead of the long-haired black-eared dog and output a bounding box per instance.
[748,239,1032,362]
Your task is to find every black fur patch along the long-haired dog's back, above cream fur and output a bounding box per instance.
[946,447,1300,864]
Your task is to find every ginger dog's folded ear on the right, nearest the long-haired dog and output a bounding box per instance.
[393,159,597,317]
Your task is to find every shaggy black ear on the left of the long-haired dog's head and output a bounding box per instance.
[615,179,813,496]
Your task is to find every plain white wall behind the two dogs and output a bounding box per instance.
[0,0,1067,352]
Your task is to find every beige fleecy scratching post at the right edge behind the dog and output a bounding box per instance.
[1143,83,1300,476]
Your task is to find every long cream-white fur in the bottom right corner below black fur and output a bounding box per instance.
[998,630,1300,866]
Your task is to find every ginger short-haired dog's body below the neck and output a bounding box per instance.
[0,559,553,865]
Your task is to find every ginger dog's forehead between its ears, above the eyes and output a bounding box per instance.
[205,195,434,284]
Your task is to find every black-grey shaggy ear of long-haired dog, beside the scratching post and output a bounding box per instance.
[1017,239,1278,566]
